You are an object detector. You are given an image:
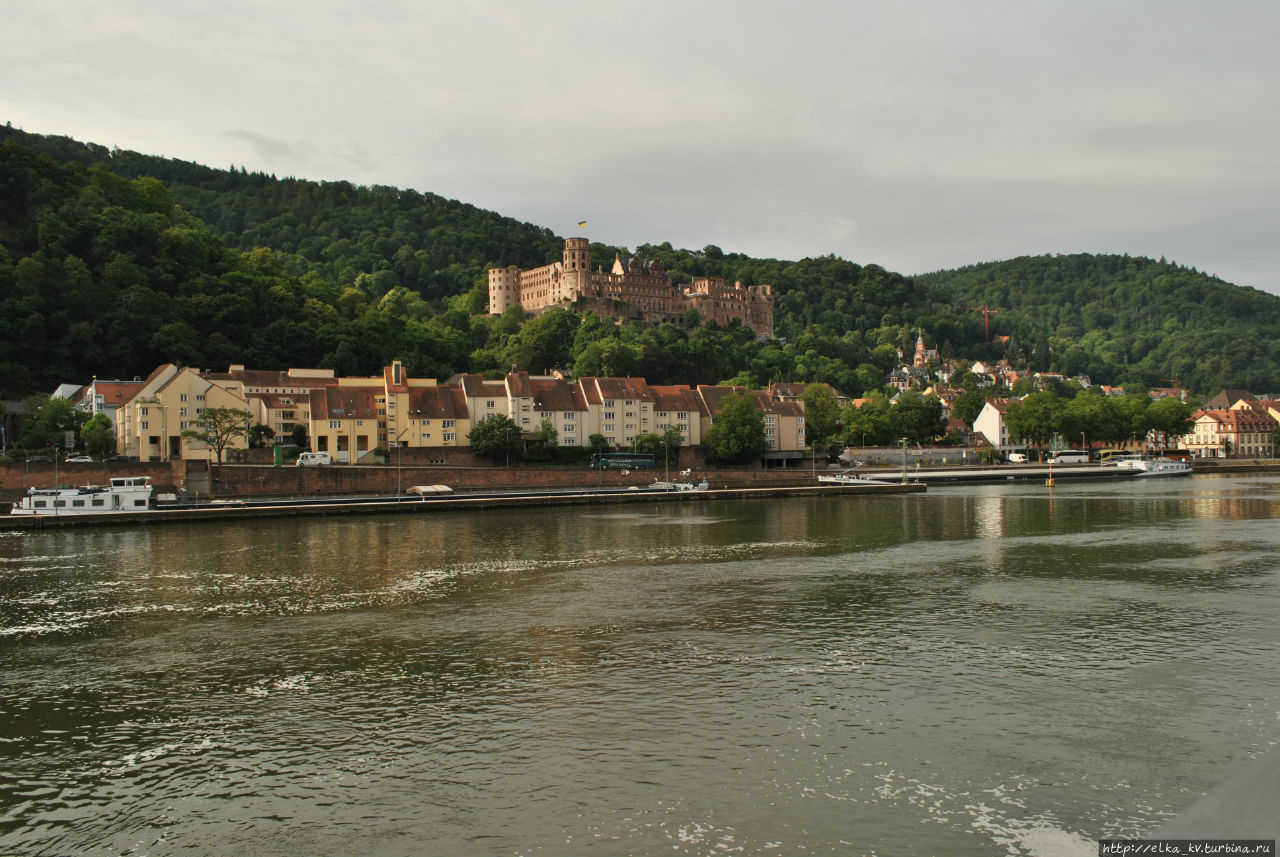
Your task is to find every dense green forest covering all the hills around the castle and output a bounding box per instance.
[0,127,1280,398]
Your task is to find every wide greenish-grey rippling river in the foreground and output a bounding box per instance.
[0,477,1280,857]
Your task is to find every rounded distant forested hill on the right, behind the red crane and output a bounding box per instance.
[915,253,1280,393]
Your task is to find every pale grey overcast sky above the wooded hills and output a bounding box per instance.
[0,0,1280,294]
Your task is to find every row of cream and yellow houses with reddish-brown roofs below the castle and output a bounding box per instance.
[79,361,808,463]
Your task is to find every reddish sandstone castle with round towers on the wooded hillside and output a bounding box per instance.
[489,238,773,339]
